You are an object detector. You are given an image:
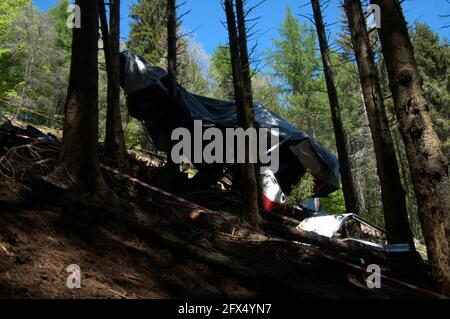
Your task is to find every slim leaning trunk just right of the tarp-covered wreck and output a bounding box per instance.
[311,0,359,213]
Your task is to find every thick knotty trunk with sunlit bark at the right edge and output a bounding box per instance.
[371,0,450,294]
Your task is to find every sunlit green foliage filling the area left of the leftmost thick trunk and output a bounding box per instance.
[0,1,69,126]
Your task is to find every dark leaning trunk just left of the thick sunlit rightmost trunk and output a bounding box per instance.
[344,0,415,249]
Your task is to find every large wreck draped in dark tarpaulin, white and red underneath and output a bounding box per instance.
[121,51,339,212]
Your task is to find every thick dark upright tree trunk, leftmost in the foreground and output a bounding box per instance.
[61,0,99,193]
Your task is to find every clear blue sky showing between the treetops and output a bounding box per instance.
[33,0,450,54]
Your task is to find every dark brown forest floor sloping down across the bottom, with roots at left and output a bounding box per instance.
[0,118,436,299]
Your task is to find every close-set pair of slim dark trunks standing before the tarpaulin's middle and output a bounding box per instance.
[225,0,261,226]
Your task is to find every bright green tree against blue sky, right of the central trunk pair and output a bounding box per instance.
[266,7,334,147]
